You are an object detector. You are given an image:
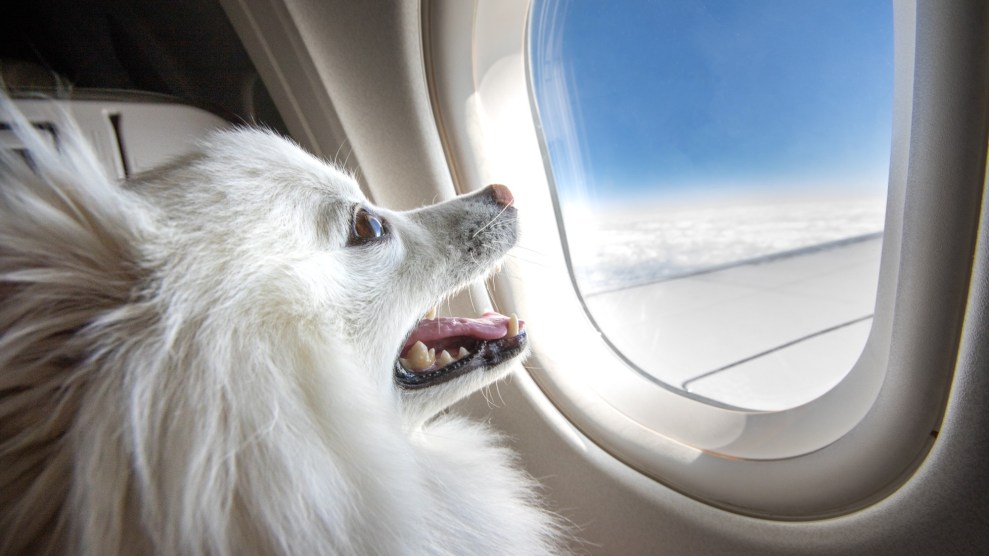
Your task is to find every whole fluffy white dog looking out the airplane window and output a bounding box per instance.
[0,97,563,555]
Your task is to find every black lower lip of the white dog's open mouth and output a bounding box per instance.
[395,331,528,390]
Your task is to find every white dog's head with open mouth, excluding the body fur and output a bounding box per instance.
[132,130,527,423]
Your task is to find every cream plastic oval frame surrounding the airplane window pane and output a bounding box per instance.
[422,0,985,519]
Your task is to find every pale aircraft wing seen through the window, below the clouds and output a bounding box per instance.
[586,236,882,410]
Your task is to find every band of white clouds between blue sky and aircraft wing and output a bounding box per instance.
[567,194,885,295]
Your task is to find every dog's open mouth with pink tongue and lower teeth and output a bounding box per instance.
[395,312,527,389]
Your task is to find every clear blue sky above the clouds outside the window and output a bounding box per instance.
[532,0,893,201]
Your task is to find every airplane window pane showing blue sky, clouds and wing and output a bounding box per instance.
[530,0,893,411]
